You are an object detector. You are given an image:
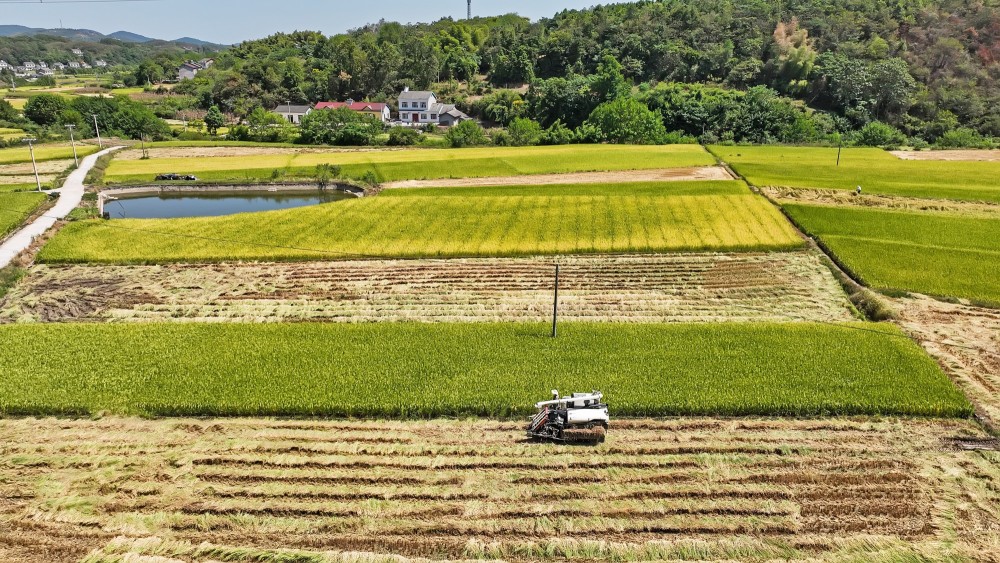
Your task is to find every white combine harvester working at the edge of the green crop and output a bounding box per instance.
[528,391,609,444]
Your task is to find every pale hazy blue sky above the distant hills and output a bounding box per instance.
[0,0,613,43]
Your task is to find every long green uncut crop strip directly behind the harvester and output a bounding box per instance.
[0,323,971,417]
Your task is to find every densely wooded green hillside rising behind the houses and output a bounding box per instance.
[164,0,1000,142]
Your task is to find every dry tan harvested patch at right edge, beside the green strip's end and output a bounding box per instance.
[894,297,1000,429]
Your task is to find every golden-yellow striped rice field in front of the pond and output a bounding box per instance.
[39,181,804,264]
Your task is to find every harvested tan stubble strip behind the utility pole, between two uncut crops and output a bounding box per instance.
[0,252,852,322]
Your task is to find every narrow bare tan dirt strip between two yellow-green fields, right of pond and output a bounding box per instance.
[383,166,735,189]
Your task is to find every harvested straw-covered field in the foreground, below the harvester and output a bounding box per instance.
[0,418,1000,563]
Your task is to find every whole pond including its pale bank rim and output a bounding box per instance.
[101,186,360,219]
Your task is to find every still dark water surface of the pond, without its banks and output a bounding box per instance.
[104,190,354,219]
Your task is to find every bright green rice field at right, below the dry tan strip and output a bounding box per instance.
[784,204,1000,304]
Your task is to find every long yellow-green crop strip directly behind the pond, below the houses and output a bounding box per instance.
[105,145,715,183]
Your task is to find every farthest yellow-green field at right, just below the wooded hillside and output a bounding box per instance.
[711,146,1000,202]
